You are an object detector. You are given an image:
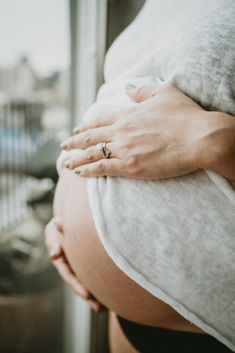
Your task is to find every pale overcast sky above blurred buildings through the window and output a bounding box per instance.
[0,0,69,75]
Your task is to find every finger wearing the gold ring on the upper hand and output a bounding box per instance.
[65,143,115,170]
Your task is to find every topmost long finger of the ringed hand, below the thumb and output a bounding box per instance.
[73,110,118,134]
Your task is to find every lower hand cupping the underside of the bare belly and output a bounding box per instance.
[45,218,106,312]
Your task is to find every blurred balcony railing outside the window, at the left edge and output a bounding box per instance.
[0,101,44,235]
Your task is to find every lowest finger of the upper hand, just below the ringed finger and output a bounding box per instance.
[74,158,123,178]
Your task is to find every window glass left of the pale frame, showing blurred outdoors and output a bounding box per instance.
[0,0,70,353]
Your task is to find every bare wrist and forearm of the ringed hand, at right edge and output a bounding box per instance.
[198,112,235,181]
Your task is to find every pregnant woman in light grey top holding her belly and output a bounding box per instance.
[46,0,235,353]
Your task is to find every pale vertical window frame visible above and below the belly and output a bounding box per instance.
[65,0,108,353]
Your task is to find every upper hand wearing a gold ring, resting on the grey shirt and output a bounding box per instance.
[61,85,213,179]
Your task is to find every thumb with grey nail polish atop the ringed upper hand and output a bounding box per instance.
[126,84,158,103]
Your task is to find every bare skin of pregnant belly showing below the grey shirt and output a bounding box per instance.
[54,170,202,332]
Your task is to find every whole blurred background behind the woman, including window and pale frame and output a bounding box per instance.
[0,0,144,353]
